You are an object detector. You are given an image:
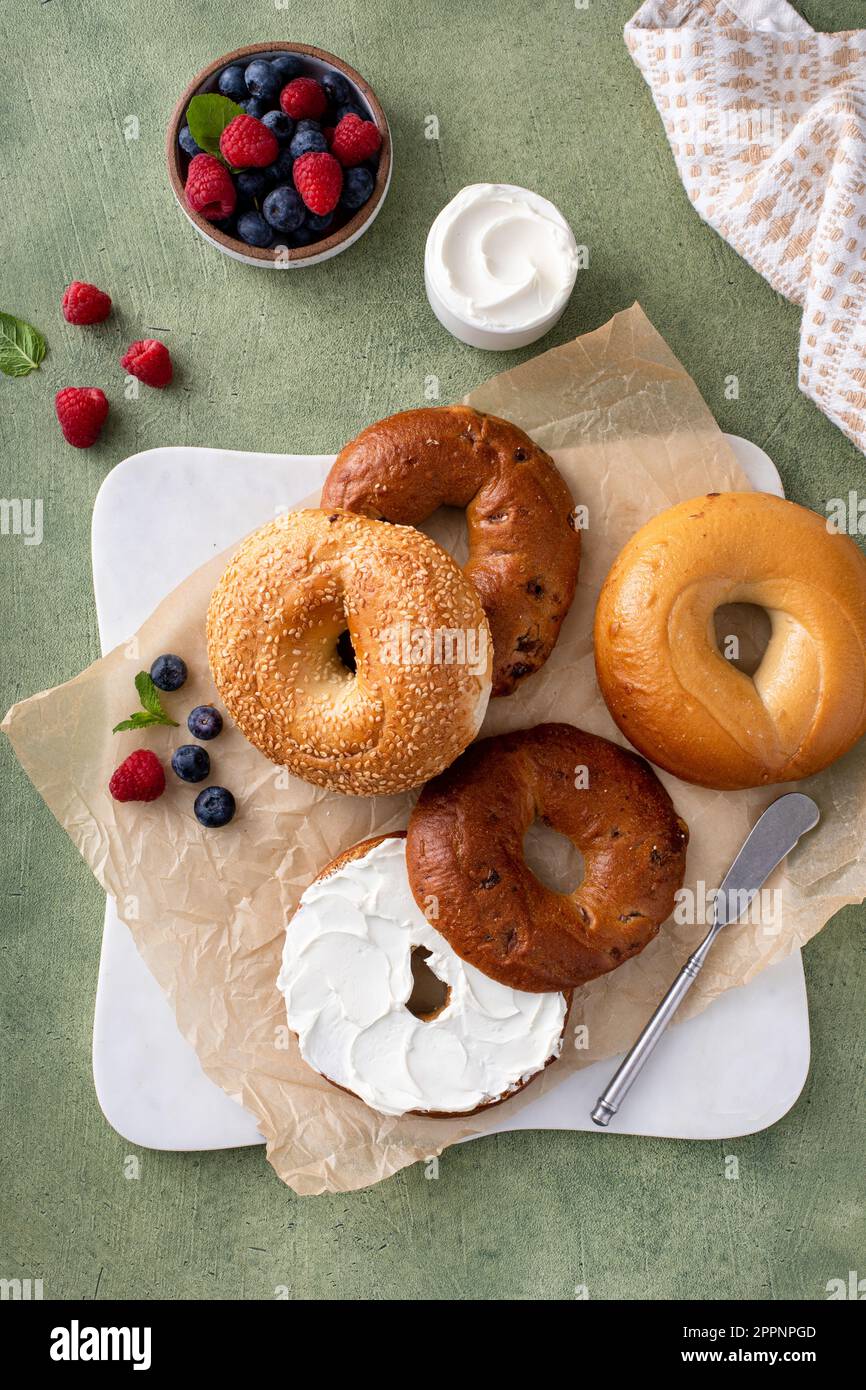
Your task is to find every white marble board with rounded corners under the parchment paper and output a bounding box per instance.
[92,436,809,1150]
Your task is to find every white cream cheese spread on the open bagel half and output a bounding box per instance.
[277,838,567,1115]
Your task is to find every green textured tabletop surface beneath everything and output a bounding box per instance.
[0,0,866,1298]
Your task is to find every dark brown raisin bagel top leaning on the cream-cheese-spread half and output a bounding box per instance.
[406,724,688,991]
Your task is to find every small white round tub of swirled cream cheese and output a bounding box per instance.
[424,183,578,350]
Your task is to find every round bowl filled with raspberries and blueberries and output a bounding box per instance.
[167,43,391,268]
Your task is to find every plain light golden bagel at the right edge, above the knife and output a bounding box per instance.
[595,492,866,790]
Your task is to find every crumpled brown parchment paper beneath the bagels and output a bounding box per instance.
[3,306,866,1194]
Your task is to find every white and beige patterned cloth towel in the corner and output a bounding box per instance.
[626,0,866,450]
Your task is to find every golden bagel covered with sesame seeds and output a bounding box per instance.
[207,510,492,796]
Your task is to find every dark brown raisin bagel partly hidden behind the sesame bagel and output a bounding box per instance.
[321,406,580,695]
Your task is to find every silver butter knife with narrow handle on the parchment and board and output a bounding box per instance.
[591,791,820,1129]
